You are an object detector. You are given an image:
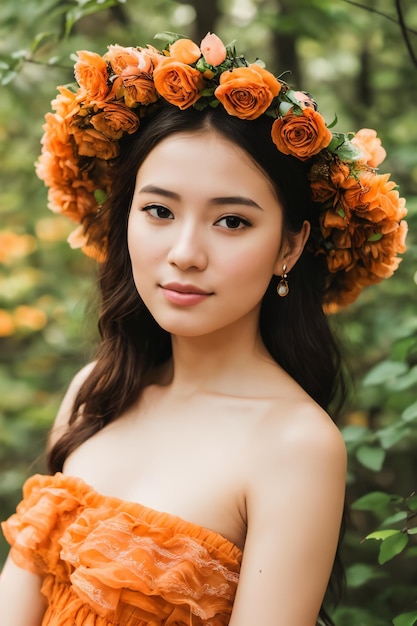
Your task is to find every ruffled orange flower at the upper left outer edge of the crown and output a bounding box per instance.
[74,50,109,103]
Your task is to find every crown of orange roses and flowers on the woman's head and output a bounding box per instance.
[36,33,407,311]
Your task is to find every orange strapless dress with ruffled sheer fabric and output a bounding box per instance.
[2,473,242,626]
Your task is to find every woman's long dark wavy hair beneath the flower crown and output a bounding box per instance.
[48,105,344,626]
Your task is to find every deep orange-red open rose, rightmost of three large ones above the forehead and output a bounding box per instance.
[271,107,332,161]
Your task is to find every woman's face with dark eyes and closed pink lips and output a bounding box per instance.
[128,131,300,336]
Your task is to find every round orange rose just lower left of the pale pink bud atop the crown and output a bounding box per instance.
[154,58,204,110]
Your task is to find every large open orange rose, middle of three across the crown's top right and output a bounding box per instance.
[214,63,281,120]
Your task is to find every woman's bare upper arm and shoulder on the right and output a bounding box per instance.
[230,406,346,626]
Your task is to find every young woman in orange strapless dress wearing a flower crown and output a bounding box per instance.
[0,30,406,626]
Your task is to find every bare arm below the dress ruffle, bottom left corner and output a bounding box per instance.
[0,557,46,626]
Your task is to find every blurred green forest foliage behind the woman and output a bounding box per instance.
[0,0,417,626]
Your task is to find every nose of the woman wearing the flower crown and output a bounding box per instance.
[168,222,208,271]
